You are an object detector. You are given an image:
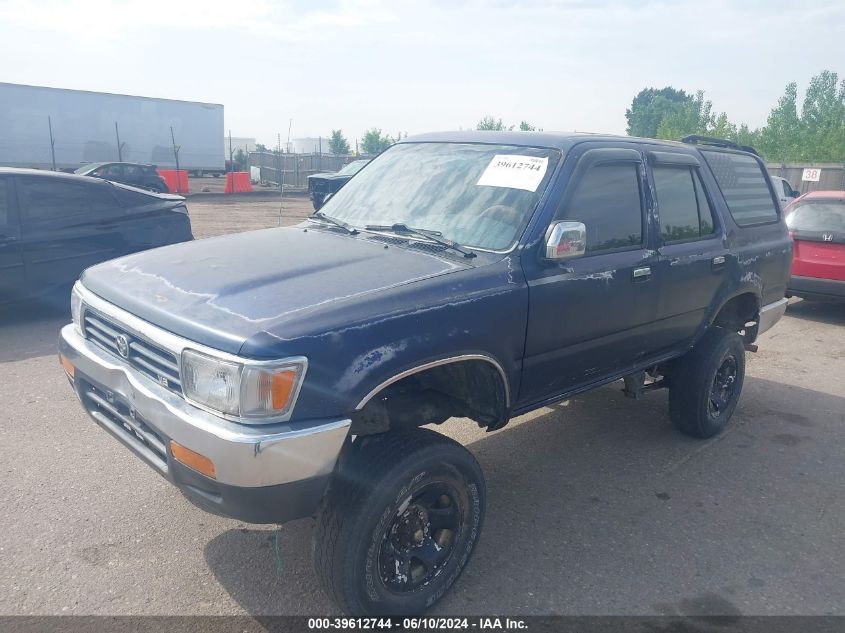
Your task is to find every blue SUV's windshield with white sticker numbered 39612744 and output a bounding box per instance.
[321,143,560,251]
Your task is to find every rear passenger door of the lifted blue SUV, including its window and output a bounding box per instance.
[649,150,728,351]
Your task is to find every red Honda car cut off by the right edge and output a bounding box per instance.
[785,191,845,301]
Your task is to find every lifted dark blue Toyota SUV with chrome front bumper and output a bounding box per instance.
[60,132,792,614]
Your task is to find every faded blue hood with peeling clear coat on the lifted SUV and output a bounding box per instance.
[82,227,469,354]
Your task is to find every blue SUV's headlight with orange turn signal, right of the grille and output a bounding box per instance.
[182,349,307,423]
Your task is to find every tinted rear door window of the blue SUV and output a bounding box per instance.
[652,167,714,243]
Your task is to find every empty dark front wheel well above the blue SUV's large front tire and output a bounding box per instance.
[351,359,508,435]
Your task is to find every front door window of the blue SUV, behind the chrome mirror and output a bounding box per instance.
[561,163,643,253]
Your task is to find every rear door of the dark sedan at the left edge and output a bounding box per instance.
[17,176,120,288]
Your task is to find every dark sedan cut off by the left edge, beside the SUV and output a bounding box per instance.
[0,168,193,304]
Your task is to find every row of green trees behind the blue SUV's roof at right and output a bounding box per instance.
[625,70,845,162]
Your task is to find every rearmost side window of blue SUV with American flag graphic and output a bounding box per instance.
[701,150,778,226]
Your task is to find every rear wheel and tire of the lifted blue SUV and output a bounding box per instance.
[669,327,745,438]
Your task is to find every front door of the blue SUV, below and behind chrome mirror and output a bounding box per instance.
[519,144,658,406]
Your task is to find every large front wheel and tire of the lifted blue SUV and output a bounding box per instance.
[314,429,485,616]
